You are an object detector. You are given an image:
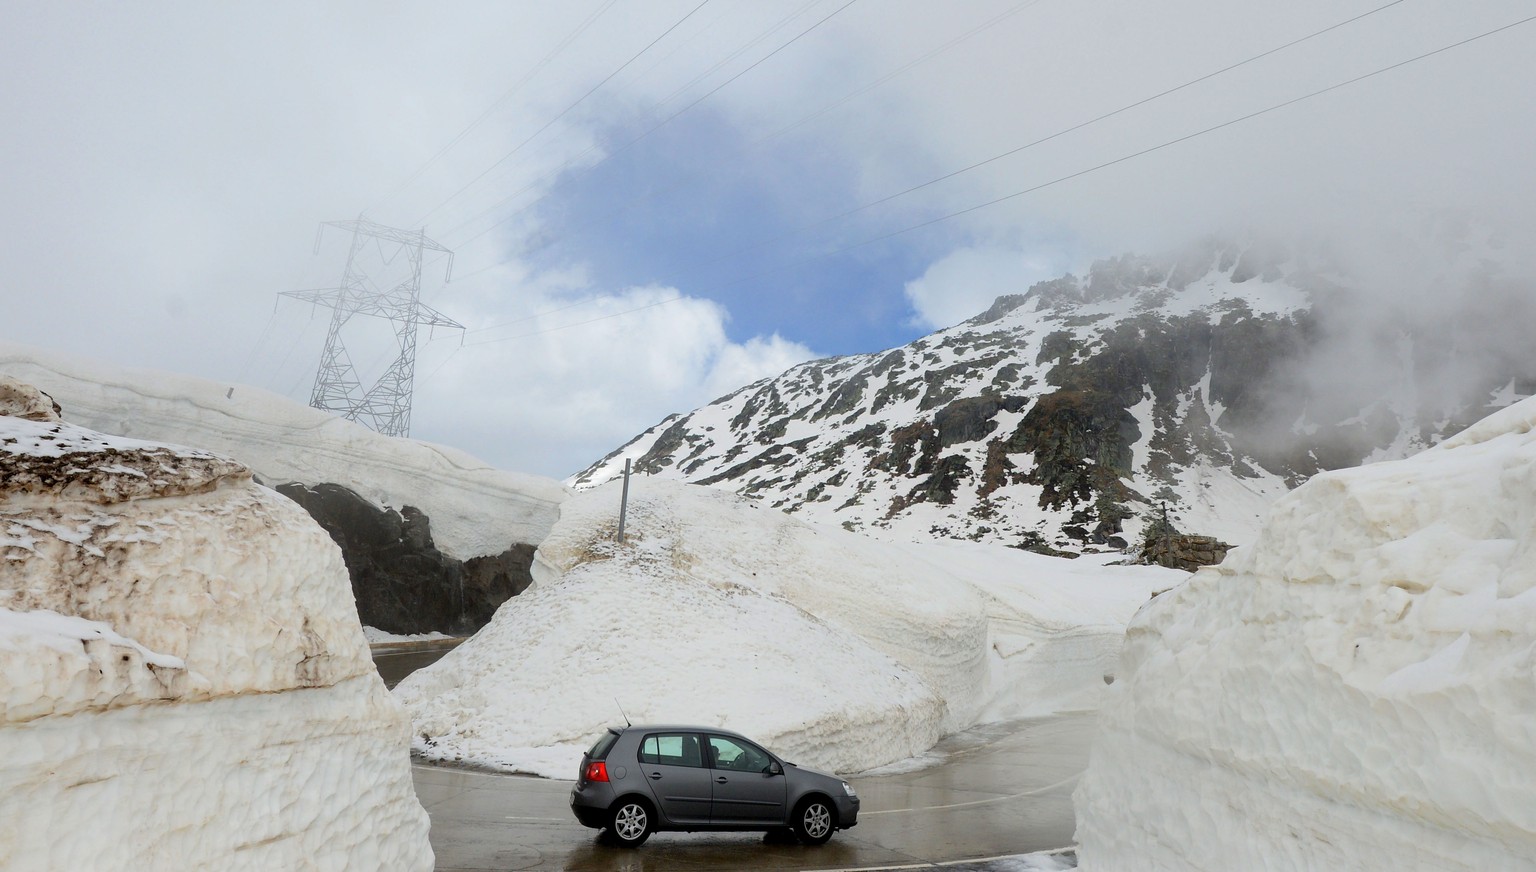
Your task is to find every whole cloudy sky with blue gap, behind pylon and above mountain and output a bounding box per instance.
[0,0,1536,477]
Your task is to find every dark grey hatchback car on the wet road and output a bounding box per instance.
[571,725,859,847]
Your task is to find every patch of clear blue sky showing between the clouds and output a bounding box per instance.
[533,107,954,355]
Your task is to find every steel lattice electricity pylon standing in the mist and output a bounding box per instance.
[281,218,464,436]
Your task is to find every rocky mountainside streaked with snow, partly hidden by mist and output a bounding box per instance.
[571,243,1530,551]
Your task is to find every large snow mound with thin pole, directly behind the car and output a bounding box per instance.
[395,479,1184,777]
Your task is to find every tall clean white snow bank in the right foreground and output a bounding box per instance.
[1075,401,1536,872]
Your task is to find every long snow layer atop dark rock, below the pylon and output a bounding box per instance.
[0,342,565,560]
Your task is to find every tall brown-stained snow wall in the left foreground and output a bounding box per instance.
[0,376,433,872]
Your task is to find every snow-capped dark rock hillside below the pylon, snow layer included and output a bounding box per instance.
[0,342,565,633]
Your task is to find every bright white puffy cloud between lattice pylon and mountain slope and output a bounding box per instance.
[413,286,814,477]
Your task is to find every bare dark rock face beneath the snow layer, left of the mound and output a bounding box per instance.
[276,484,533,636]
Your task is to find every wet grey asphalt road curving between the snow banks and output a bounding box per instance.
[375,641,1095,872]
